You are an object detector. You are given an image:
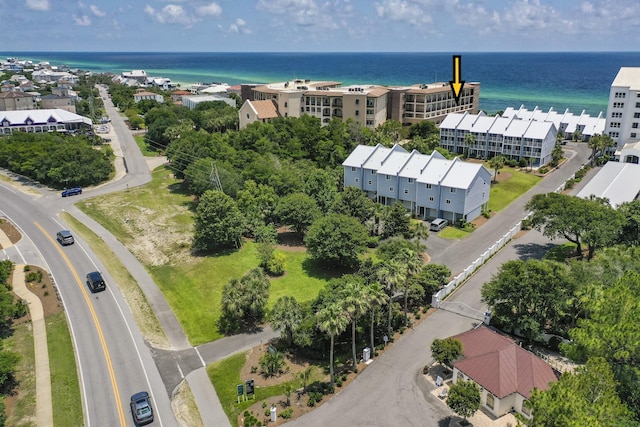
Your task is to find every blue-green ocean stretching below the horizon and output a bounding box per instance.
[0,52,640,115]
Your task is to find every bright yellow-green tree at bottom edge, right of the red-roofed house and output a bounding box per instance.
[525,357,634,427]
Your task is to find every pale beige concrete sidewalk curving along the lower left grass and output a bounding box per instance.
[11,264,53,427]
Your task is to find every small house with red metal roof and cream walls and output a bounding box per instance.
[452,326,558,418]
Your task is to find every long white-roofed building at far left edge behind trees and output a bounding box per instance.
[0,108,93,135]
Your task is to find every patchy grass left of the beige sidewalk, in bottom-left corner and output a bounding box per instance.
[2,323,35,427]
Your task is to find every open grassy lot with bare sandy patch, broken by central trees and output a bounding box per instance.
[78,167,332,345]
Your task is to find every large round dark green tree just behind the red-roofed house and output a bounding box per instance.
[481,259,572,340]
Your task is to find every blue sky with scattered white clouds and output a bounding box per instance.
[0,0,640,52]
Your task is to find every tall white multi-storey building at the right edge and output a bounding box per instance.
[605,67,640,159]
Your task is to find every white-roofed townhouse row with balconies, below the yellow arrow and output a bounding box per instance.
[440,112,558,166]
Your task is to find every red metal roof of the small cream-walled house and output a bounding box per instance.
[452,327,558,399]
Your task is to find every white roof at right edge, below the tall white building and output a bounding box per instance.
[578,162,640,208]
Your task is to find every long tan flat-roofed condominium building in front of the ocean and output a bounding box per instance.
[241,79,480,129]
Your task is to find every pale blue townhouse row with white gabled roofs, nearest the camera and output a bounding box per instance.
[342,144,491,222]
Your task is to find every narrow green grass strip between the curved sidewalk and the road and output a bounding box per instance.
[46,313,84,426]
